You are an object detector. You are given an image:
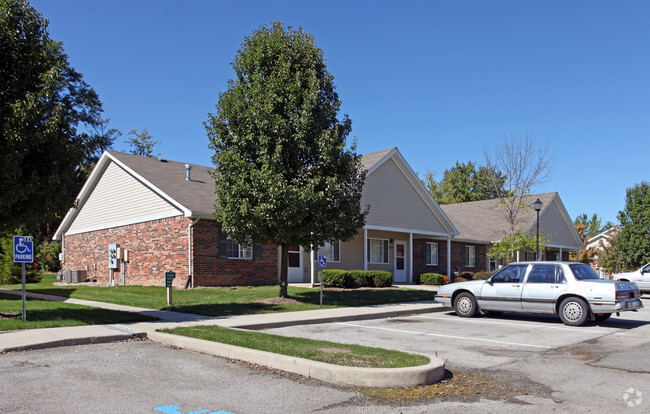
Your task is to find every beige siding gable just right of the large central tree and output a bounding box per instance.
[361,159,446,233]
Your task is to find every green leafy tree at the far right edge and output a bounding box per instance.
[616,181,650,270]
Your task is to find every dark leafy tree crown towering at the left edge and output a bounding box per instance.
[0,0,110,231]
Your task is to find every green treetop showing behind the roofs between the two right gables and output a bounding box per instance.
[423,161,505,204]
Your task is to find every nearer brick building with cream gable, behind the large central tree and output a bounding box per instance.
[54,148,458,286]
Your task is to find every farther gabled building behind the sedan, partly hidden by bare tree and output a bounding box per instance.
[441,193,584,273]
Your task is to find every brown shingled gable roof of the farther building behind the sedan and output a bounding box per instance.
[441,192,582,247]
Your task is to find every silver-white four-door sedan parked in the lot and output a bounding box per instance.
[435,262,643,326]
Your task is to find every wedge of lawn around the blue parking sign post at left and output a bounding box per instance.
[0,293,156,331]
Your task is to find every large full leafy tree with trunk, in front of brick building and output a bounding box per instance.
[206,22,367,297]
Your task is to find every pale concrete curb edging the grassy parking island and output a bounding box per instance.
[147,332,445,387]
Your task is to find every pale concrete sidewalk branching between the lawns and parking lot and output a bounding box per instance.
[0,289,446,353]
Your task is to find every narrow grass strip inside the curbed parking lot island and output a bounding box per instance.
[161,326,429,368]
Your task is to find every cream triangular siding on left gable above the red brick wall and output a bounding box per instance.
[66,162,182,234]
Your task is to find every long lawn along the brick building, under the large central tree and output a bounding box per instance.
[2,273,434,316]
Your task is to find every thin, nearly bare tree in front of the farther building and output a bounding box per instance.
[483,133,554,253]
